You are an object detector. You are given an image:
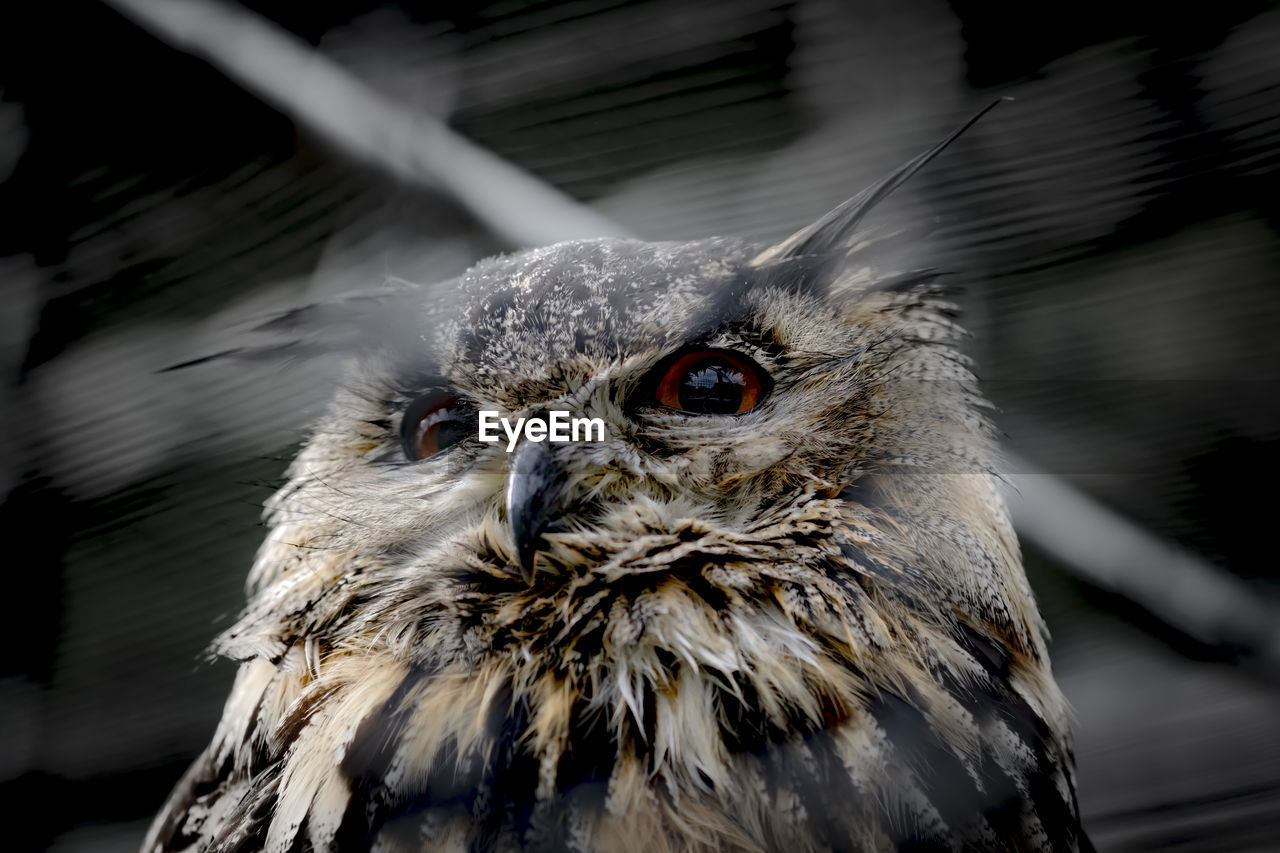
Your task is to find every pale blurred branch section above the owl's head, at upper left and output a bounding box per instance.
[104,0,623,246]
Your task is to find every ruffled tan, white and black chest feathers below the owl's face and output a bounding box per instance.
[154,491,1075,850]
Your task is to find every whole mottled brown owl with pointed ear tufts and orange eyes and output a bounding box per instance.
[143,112,1089,853]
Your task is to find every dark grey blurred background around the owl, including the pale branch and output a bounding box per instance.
[0,0,1280,852]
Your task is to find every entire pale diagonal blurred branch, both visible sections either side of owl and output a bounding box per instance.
[104,0,1280,671]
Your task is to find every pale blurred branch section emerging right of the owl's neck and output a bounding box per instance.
[1006,453,1280,674]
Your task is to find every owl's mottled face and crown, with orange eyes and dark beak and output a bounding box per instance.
[275,233,980,580]
